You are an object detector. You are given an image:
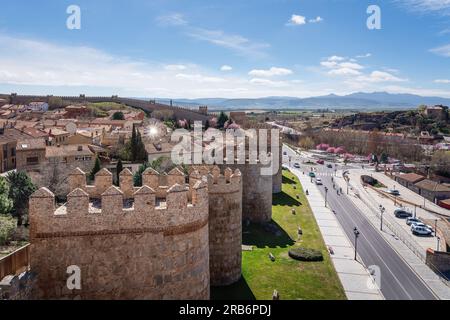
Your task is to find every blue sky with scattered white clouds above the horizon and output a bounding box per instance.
[0,0,450,98]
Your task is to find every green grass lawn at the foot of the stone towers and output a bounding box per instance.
[211,171,345,300]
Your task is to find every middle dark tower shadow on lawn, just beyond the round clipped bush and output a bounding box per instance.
[242,220,295,248]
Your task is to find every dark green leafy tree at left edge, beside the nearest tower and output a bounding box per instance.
[6,171,37,226]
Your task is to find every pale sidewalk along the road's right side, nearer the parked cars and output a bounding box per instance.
[335,172,450,300]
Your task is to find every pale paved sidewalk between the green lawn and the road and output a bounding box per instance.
[291,168,384,300]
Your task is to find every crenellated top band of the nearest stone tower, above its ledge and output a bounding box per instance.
[30,174,208,238]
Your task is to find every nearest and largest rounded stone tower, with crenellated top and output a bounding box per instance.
[30,172,210,300]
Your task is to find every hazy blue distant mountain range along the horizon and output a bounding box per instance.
[157,92,450,110]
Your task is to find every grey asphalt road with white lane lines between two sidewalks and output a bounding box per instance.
[285,150,436,300]
